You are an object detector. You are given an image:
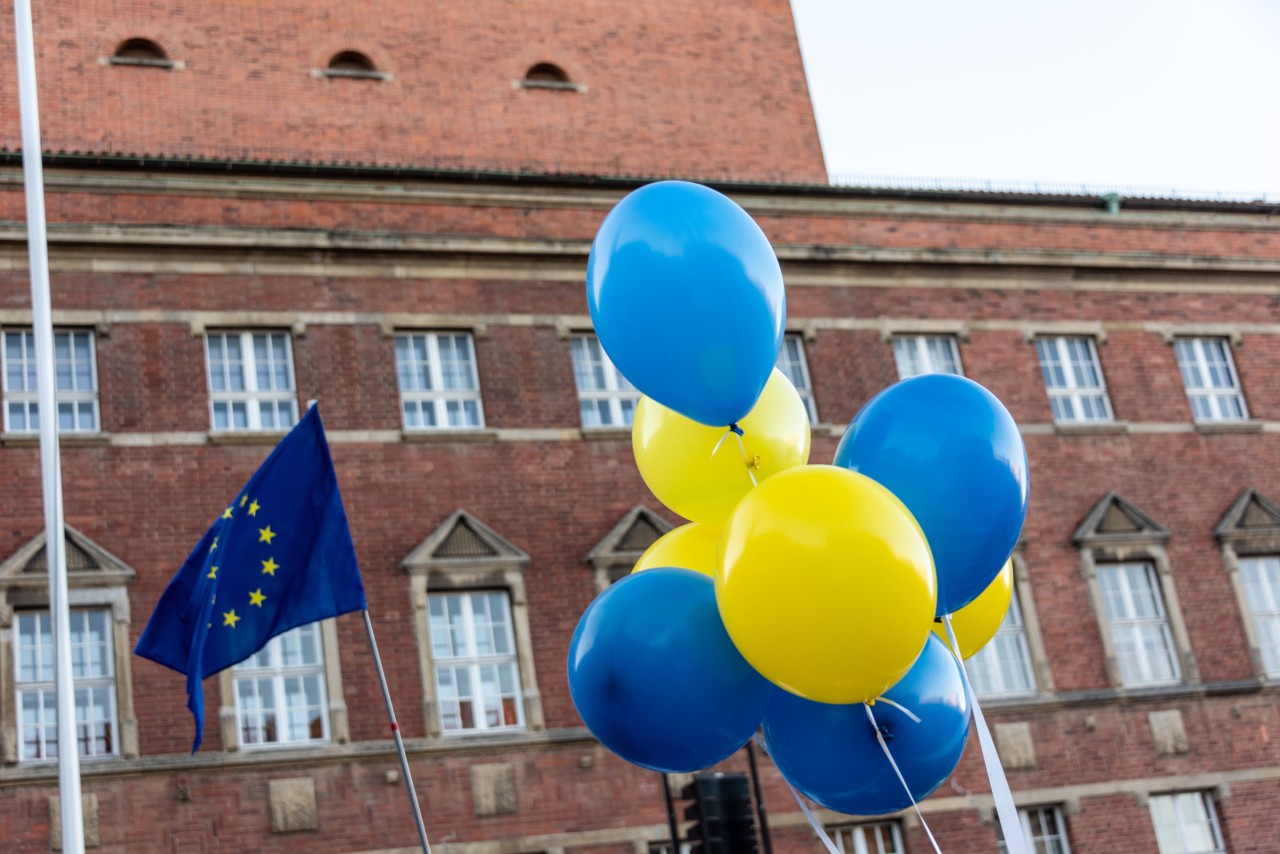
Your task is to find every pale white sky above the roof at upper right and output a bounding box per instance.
[791,0,1280,200]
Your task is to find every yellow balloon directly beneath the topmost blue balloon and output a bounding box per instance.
[631,367,809,525]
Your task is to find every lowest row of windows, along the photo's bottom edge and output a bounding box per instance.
[665,791,1226,854]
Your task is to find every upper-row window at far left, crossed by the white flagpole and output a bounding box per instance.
[3,329,99,433]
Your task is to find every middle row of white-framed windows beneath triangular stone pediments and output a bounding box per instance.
[14,535,1280,762]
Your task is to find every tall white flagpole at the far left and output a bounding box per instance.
[13,0,84,854]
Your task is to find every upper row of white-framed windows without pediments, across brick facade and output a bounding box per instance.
[0,330,1248,433]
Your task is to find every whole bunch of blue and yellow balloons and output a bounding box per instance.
[568,182,1028,814]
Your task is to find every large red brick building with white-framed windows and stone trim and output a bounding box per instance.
[0,0,1280,854]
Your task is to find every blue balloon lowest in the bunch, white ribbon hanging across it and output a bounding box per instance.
[764,634,969,816]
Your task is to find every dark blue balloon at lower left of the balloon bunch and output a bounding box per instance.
[568,568,776,773]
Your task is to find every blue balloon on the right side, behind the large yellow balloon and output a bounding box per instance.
[835,374,1028,616]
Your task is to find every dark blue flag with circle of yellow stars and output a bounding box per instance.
[133,406,367,753]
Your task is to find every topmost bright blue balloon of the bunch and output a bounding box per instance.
[586,181,787,426]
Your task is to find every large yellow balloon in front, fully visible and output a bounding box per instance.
[716,466,937,704]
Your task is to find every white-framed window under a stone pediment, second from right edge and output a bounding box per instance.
[1098,561,1181,686]
